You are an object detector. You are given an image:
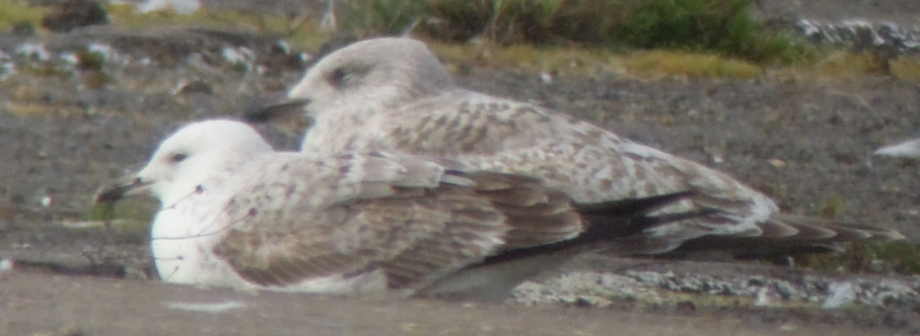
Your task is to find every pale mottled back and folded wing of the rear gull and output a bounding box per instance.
[352,90,778,241]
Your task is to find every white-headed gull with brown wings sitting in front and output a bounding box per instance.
[99,120,697,300]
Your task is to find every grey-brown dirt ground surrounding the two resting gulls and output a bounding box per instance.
[0,0,920,335]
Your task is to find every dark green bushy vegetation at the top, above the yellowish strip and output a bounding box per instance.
[352,0,814,64]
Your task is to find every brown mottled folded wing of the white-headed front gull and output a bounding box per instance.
[214,154,507,289]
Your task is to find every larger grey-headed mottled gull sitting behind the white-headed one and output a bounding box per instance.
[274,38,903,253]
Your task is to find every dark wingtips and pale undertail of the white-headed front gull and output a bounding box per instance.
[417,192,710,302]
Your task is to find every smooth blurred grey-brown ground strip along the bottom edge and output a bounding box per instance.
[0,273,906,336]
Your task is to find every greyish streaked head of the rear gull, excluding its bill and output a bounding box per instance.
[288,37,453,117]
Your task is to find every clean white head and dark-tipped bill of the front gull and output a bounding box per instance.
[96,120,274,205]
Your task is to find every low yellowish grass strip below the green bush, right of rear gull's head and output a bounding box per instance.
[410,41,920,82]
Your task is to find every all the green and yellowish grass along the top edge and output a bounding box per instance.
[0,0,920,80]
